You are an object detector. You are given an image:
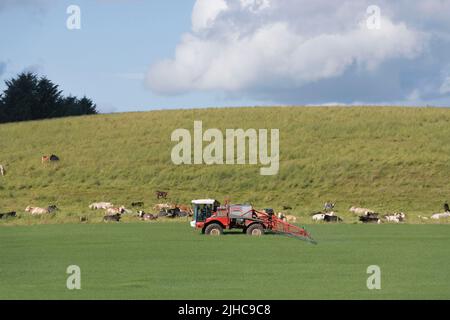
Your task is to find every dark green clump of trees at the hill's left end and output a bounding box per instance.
[0,72,98,123]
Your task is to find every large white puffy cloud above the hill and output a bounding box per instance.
[146,0,450,102]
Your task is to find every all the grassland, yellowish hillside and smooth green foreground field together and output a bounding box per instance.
[0,107,450,299]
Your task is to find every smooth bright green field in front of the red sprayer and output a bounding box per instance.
[0,223,450,299]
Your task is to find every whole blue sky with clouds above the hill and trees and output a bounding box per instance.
[0,0,450,113]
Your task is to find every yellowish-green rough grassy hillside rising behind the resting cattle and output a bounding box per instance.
[0,107,450,224]
